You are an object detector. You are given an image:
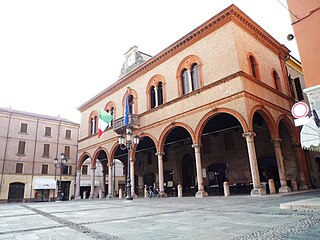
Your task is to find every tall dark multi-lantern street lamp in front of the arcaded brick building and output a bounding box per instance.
[118,126,139,200]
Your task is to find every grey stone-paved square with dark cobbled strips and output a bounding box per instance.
[0,191,320,240]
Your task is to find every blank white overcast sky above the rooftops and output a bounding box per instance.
[0,0,300,123]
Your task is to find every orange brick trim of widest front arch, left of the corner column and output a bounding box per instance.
[195,108,249,144]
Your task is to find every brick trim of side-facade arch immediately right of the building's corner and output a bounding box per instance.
[249,105,279,139]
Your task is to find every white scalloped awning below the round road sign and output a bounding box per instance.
[300,118,320,152]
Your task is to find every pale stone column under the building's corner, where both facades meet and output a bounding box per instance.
[242,132,266,196]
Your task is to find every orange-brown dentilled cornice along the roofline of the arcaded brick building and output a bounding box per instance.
[78,4,290,112]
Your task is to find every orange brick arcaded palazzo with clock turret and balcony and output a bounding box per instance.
[76,5,310,198]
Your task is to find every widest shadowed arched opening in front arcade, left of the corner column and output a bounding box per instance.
[201,113,252,195]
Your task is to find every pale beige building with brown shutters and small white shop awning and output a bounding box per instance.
[0,108,79,202]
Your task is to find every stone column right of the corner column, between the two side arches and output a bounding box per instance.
[272,138,291,193]
